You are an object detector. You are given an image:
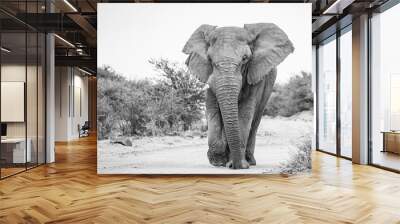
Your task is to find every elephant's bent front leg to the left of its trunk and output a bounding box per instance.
[206,89,229,166]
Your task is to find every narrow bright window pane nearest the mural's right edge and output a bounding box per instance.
[318,38,336,156]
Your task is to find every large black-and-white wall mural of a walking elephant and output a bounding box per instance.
[97,3,313,174]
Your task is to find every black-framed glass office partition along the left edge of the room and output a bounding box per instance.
[0,1,46,178]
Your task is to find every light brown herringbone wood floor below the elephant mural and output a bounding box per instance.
[0,137,400,224]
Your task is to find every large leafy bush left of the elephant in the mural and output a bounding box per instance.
[97,59,205,139]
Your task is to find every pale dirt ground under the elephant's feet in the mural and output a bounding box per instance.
[97,112,313,174]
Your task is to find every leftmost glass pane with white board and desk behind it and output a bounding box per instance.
[0,32,27,178]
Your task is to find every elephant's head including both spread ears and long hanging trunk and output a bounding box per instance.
[183,23,294,168]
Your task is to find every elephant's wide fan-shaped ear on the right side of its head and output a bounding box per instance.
[244,23,294,85]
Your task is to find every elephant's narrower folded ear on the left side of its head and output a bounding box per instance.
[182,25,216,82]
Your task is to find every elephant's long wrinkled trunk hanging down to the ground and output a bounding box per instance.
[215,72,244,168]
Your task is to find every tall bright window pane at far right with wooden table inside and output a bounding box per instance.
[371,4,400,170]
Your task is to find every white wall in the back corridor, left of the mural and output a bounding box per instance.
[55,67,88,141]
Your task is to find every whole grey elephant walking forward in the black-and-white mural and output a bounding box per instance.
[182,23,294,169]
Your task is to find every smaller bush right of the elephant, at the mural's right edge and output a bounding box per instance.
[264,72,314,117]
